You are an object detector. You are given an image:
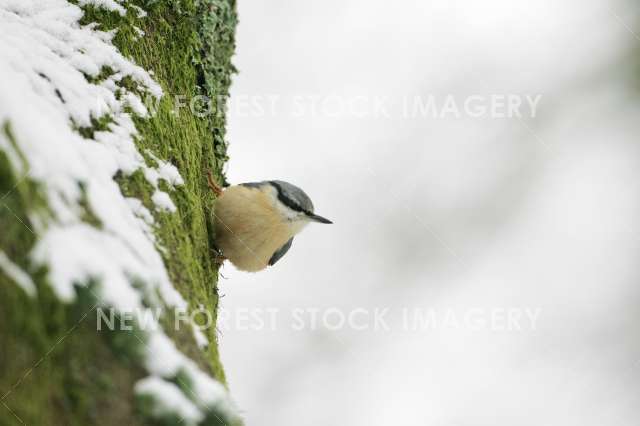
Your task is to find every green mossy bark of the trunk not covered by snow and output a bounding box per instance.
[0,0,236,426]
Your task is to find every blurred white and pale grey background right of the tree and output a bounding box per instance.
[220,0,640,426]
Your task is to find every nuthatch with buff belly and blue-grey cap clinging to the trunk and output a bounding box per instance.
[208,173,332,272]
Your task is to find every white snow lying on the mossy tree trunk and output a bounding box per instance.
[0,0,235,424]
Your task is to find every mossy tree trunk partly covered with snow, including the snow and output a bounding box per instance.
[0,0,240,426]
